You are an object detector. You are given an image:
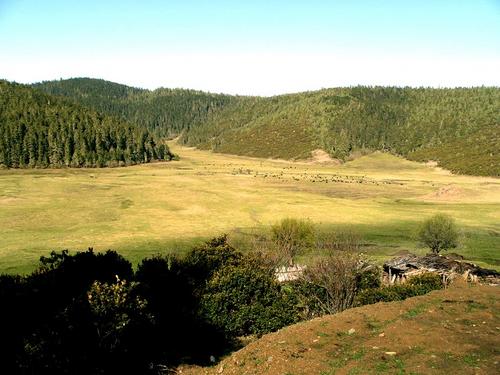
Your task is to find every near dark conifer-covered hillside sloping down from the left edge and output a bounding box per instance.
[0,80,173,168]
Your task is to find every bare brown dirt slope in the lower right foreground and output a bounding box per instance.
[179,285,500,375]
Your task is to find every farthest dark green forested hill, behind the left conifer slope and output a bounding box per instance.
[32,78,238,137]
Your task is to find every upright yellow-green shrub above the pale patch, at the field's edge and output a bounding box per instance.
[271,218,315,265]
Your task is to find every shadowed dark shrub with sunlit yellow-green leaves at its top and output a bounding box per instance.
[20,280,155,374]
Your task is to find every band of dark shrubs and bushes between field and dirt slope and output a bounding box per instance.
[0,214,466,374]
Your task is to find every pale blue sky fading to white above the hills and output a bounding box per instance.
[0,0,500,96]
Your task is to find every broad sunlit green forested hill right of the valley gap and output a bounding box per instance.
[181,87,500,176]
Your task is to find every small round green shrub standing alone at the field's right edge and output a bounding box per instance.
[418,214,458,254]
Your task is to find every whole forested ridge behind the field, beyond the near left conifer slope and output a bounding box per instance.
[33,78,500,176]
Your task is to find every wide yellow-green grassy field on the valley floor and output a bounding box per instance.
[0,144,500,272]
